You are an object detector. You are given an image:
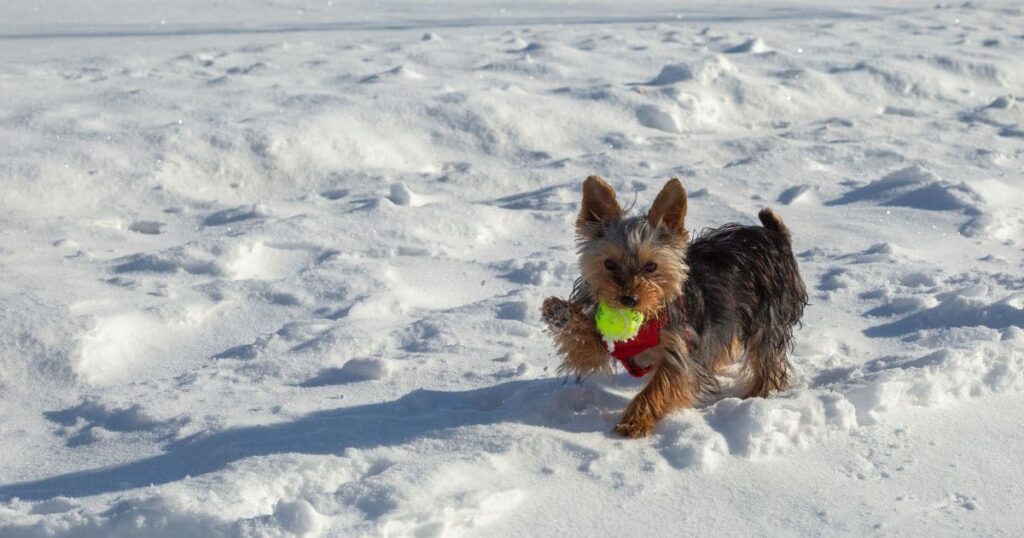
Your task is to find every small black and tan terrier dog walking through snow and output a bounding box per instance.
[541,176,807,438]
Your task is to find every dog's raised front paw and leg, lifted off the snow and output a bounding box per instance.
[541,297,611,376]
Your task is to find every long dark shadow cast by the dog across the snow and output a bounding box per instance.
[0,379,625,500]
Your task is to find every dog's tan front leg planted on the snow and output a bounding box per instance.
[615,332,717,438]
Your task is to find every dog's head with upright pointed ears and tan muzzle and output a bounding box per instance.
[577,175,689,318]
